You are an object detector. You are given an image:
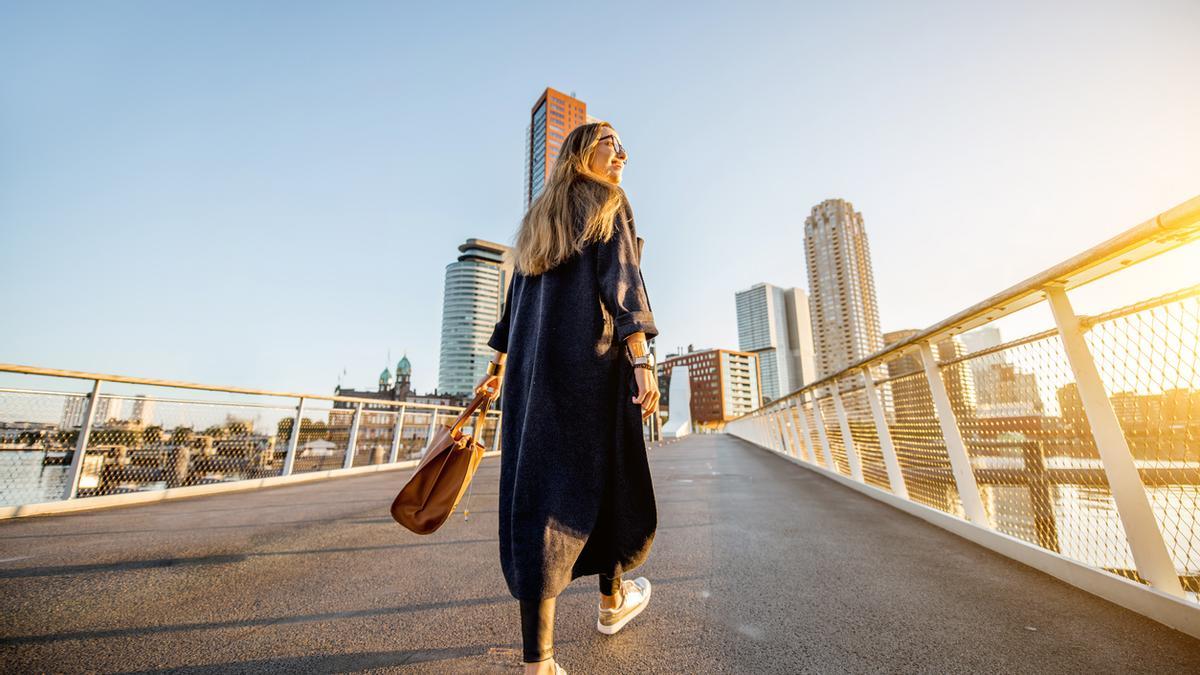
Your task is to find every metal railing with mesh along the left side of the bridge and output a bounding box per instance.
[0,364,500,507]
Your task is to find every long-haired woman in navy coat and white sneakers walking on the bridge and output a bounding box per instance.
[476,123,659,674]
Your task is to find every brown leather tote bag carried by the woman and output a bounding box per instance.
[391,394,492,534]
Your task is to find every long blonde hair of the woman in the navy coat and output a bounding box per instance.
[509,121,625,276]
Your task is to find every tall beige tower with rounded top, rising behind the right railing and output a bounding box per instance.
[804,199,883,380]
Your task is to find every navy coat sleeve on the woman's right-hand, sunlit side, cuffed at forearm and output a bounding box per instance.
[596,205,659,342]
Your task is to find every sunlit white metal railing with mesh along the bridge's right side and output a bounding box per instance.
[725,197,1200,619]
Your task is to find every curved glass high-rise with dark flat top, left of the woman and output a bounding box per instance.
[438,239,512,395]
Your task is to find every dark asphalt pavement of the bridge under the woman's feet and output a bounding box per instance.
[0,435,1200,674]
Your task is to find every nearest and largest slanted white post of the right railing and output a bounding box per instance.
[1046,286,1184,597]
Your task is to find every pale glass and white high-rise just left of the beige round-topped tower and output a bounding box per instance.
[734,282,816,401]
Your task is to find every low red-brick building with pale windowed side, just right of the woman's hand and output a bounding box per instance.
[659,345,762,429]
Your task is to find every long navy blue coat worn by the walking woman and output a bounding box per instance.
[487,195,659,599]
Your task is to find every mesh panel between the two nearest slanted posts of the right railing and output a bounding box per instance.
[941,334,1136,578]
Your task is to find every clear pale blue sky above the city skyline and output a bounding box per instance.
[0,1,1200,393]
